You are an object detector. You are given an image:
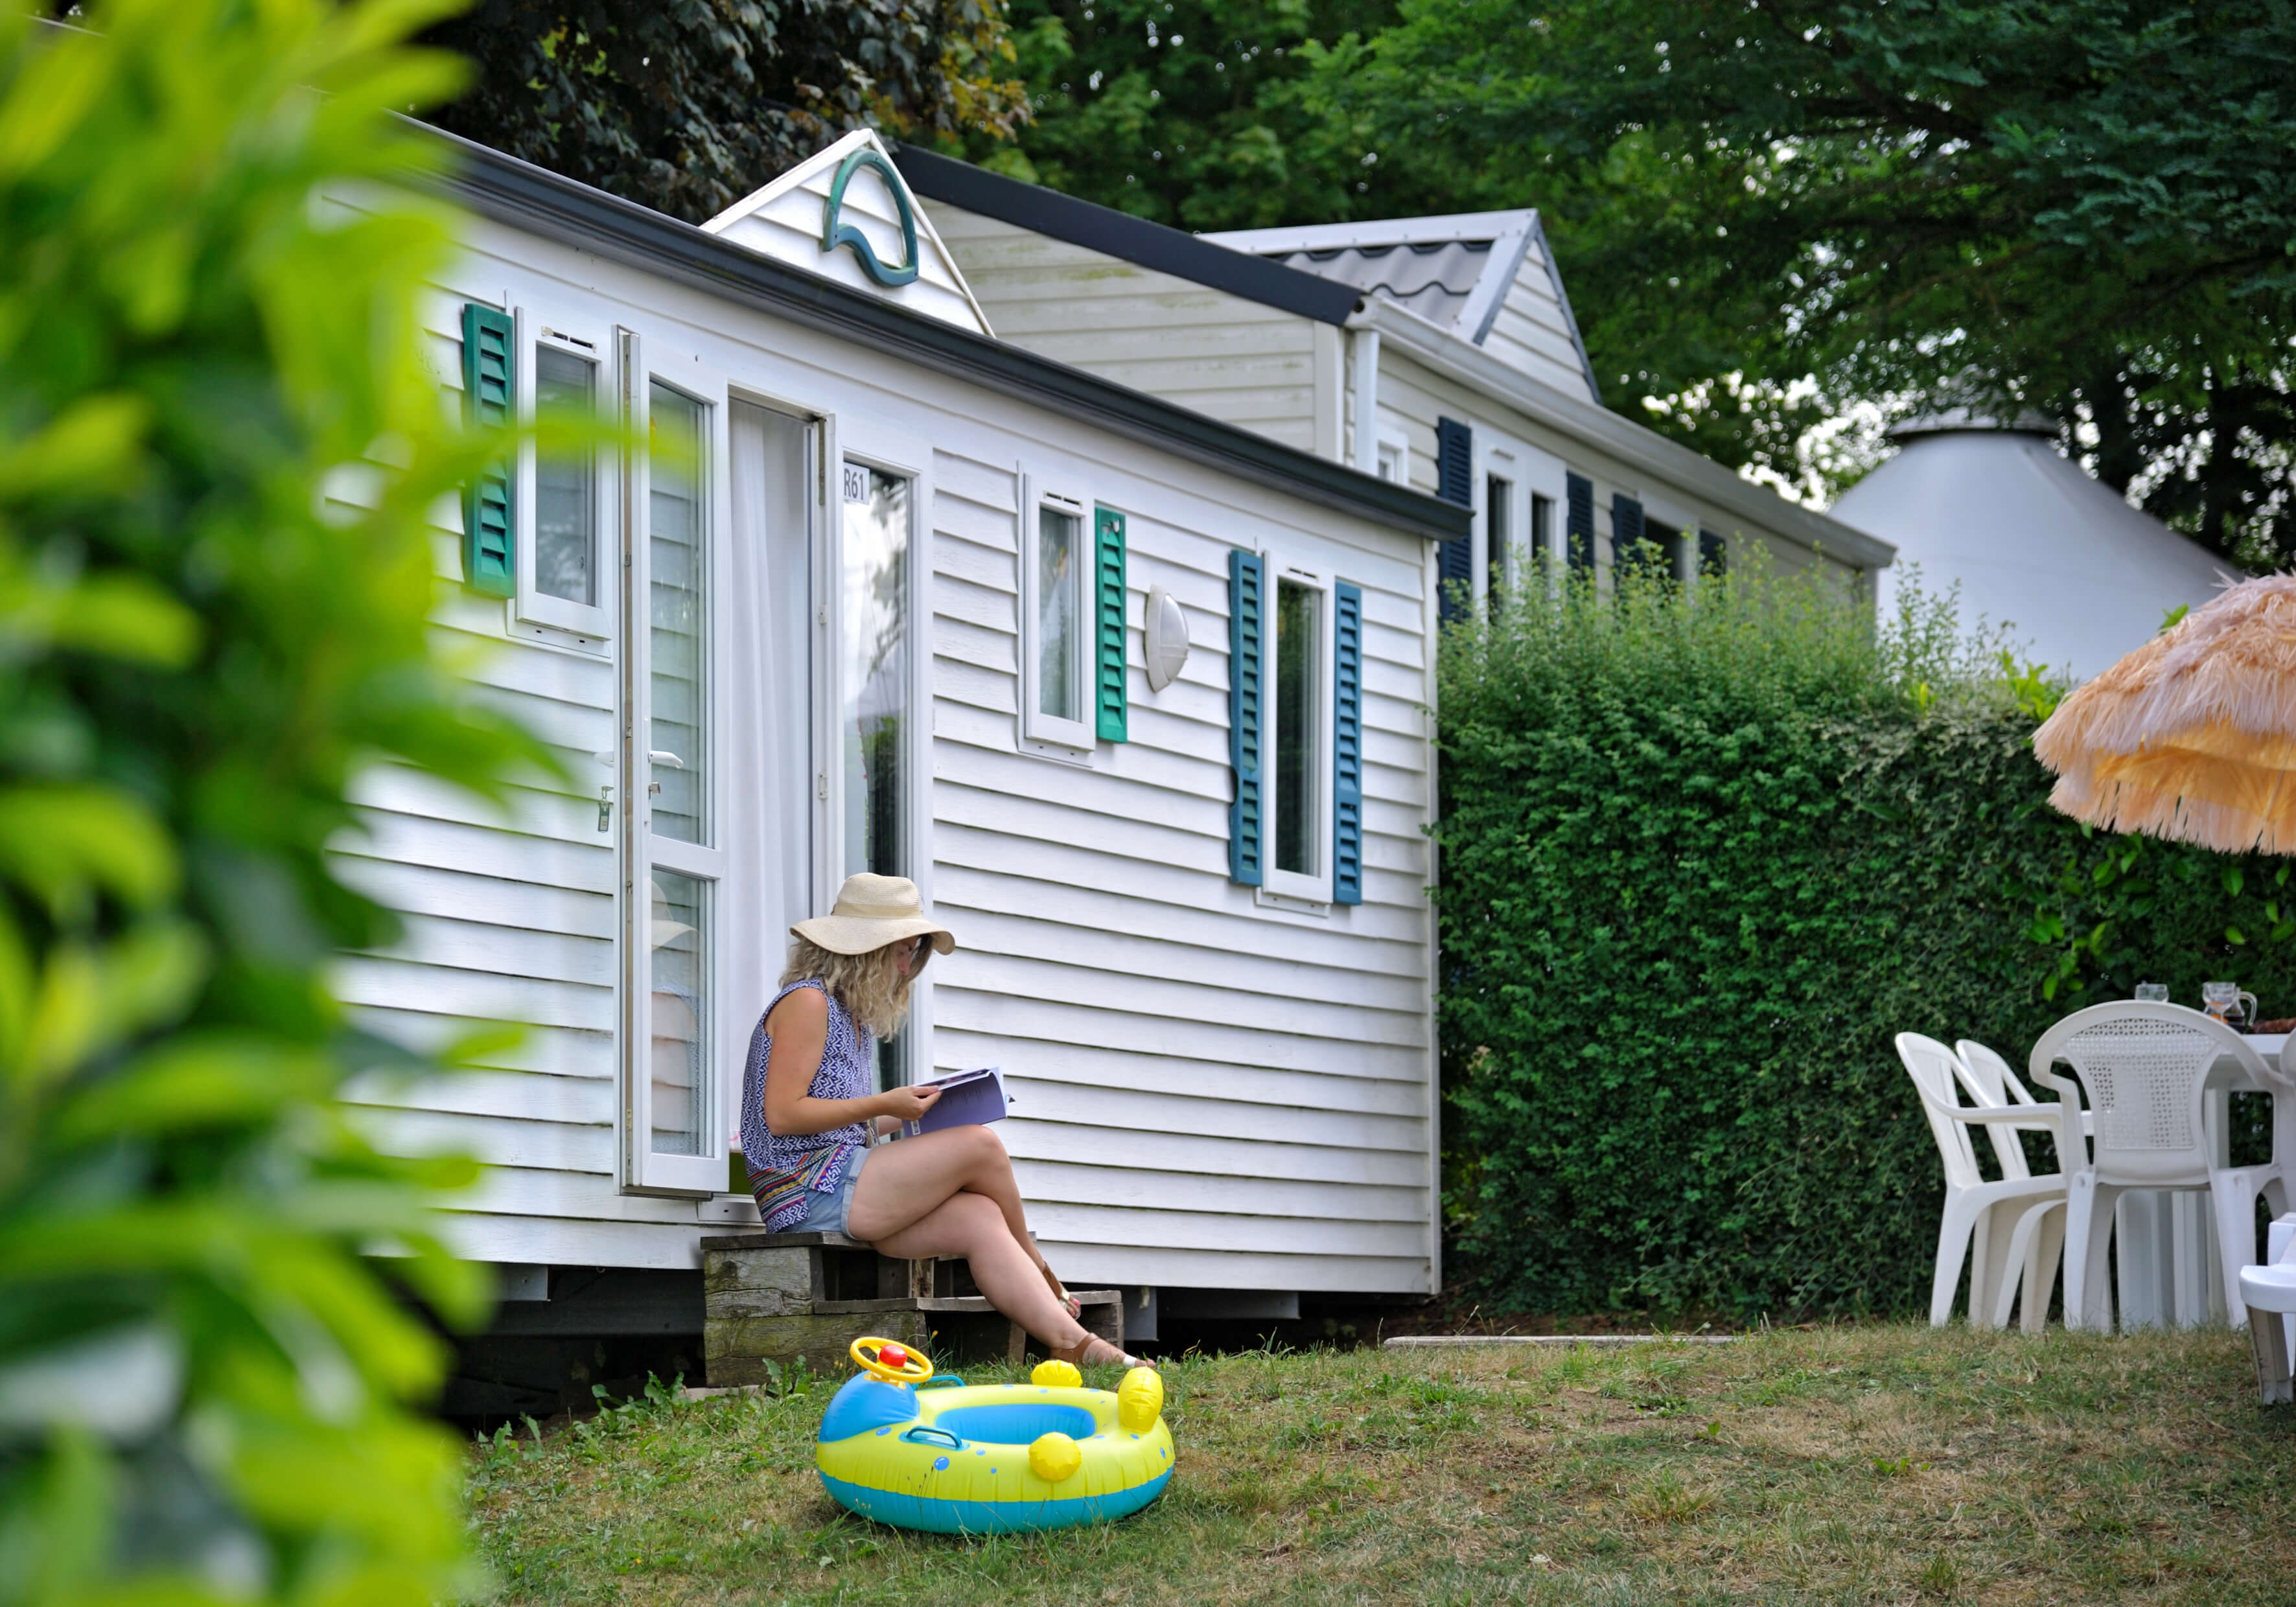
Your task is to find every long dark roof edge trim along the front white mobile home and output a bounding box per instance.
[432,131,1470,542]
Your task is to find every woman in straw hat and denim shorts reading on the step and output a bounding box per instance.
[741,872,1134,1366]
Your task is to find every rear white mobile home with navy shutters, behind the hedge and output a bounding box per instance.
[896,147,1892,597]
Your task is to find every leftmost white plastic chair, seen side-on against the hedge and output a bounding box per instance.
[1897,1033,2064,1329]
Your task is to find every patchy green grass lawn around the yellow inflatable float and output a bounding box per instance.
[470,1327,2296,1607]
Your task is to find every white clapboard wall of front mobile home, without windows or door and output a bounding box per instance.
[340,213,1435,1290]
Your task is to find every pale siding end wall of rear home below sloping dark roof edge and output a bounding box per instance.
[918,200,1318,452]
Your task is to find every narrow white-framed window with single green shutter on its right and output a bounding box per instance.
[1019,482,1098,757]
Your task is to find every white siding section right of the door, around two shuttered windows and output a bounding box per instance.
[932,450,1433,1290]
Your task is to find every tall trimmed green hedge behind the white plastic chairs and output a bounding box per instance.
[1437,576,2296,1318]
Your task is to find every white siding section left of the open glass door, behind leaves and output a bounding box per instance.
[338,289,693,1267]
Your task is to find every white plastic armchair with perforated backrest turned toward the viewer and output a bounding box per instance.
[2025,1003,2287,1332]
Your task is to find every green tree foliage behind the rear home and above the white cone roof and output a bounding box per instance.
[973,0,2296,560]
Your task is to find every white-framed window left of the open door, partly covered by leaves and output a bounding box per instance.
[510,305,616,652]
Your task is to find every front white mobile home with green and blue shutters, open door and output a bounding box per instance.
[340,135,1470,1332]
